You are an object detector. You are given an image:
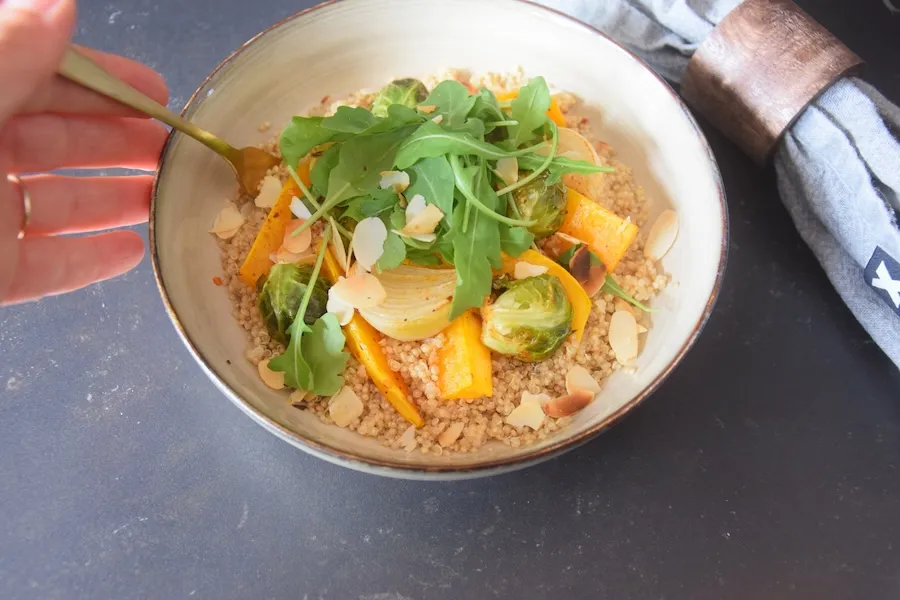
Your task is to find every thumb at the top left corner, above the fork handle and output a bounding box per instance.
[0,0,75,123]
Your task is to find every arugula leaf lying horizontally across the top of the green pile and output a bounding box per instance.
[394,121,532,170]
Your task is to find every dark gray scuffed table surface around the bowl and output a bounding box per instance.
[0,0,900,600]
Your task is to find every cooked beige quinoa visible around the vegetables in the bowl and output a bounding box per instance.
[218,71,668,455]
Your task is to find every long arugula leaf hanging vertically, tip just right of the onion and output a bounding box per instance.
[450,159,502,320]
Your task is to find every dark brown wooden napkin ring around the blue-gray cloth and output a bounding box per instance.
[681,0,862,164]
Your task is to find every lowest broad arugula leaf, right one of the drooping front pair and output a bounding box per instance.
[298,313,350,396]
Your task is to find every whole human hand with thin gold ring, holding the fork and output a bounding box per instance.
[0,0,168,305]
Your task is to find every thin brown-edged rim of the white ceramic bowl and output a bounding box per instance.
[148,0,730,478]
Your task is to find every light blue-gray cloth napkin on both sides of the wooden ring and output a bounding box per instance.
[537,0,900,368]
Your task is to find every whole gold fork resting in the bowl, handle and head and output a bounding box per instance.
[59,47,281,195]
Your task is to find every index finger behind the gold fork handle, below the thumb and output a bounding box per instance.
[21,46,169,117]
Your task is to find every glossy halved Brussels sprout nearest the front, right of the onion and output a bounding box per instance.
[481,274,573,362]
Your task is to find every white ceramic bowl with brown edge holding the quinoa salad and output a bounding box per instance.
[150,0,728,479]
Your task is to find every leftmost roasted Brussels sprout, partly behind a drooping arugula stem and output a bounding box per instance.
[256,264,328,344]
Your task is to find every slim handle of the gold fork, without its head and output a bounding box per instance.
[59,46,234,158]
